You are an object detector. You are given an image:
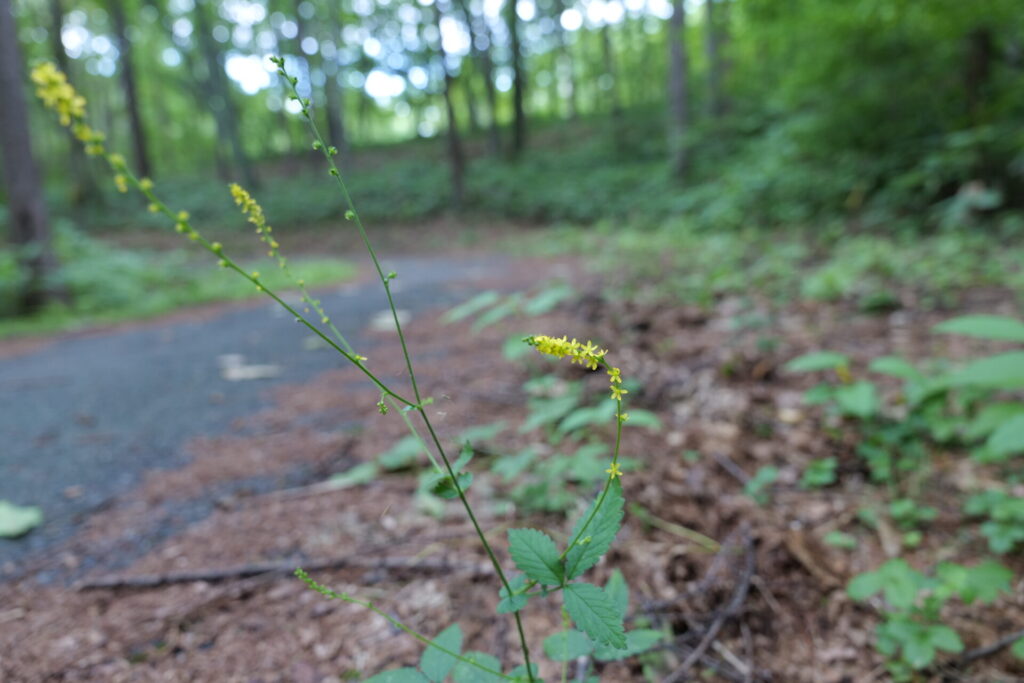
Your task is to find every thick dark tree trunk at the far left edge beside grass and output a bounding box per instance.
[0,0,64,314]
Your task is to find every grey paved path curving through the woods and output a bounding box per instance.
[0,256,511,574]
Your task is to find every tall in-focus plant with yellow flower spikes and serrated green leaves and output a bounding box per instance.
[32,57,660,683]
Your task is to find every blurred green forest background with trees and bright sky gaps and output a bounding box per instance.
[0,0,1024,333]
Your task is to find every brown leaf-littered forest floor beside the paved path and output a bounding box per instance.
[0,242,1024,683]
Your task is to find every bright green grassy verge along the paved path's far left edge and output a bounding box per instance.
[0,226,355,339]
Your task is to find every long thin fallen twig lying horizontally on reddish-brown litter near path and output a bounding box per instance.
[76,555,494,591]
